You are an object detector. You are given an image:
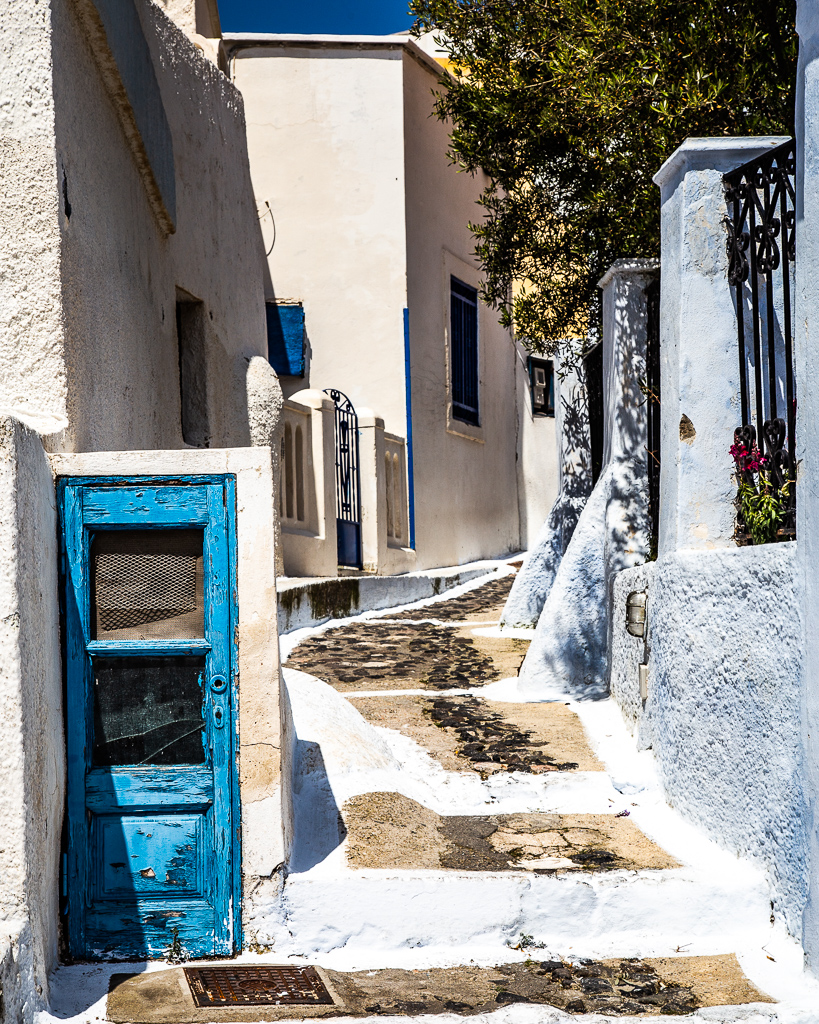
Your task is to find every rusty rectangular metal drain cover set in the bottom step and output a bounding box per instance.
[184,967,333,1007]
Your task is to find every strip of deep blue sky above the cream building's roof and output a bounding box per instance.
[219,0,413,35]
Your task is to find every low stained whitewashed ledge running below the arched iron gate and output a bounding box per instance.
[276,563,497,633]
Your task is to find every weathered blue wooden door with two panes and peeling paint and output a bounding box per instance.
[59,477,240,959]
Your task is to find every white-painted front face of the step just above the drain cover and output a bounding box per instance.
[254,868,770,965]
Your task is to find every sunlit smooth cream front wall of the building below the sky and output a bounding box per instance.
[228,43,406,434]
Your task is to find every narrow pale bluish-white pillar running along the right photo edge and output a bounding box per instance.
[793,0,819,974]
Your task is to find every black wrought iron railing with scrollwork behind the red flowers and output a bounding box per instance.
[723,139,796,543]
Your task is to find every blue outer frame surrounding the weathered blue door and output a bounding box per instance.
[56,473,243,955]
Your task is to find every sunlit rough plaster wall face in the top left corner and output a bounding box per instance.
[0,0,68,430]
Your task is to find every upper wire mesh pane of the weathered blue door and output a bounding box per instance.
[91,529,205,640]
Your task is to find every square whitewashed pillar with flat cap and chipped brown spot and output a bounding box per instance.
[654,136,787,556]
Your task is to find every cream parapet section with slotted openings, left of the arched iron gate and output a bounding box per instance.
[278,389,338,577]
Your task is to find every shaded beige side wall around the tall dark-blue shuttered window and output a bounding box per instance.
[403,52,519,568]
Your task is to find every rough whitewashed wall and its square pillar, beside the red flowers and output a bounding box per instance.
[609,138,807,937]
